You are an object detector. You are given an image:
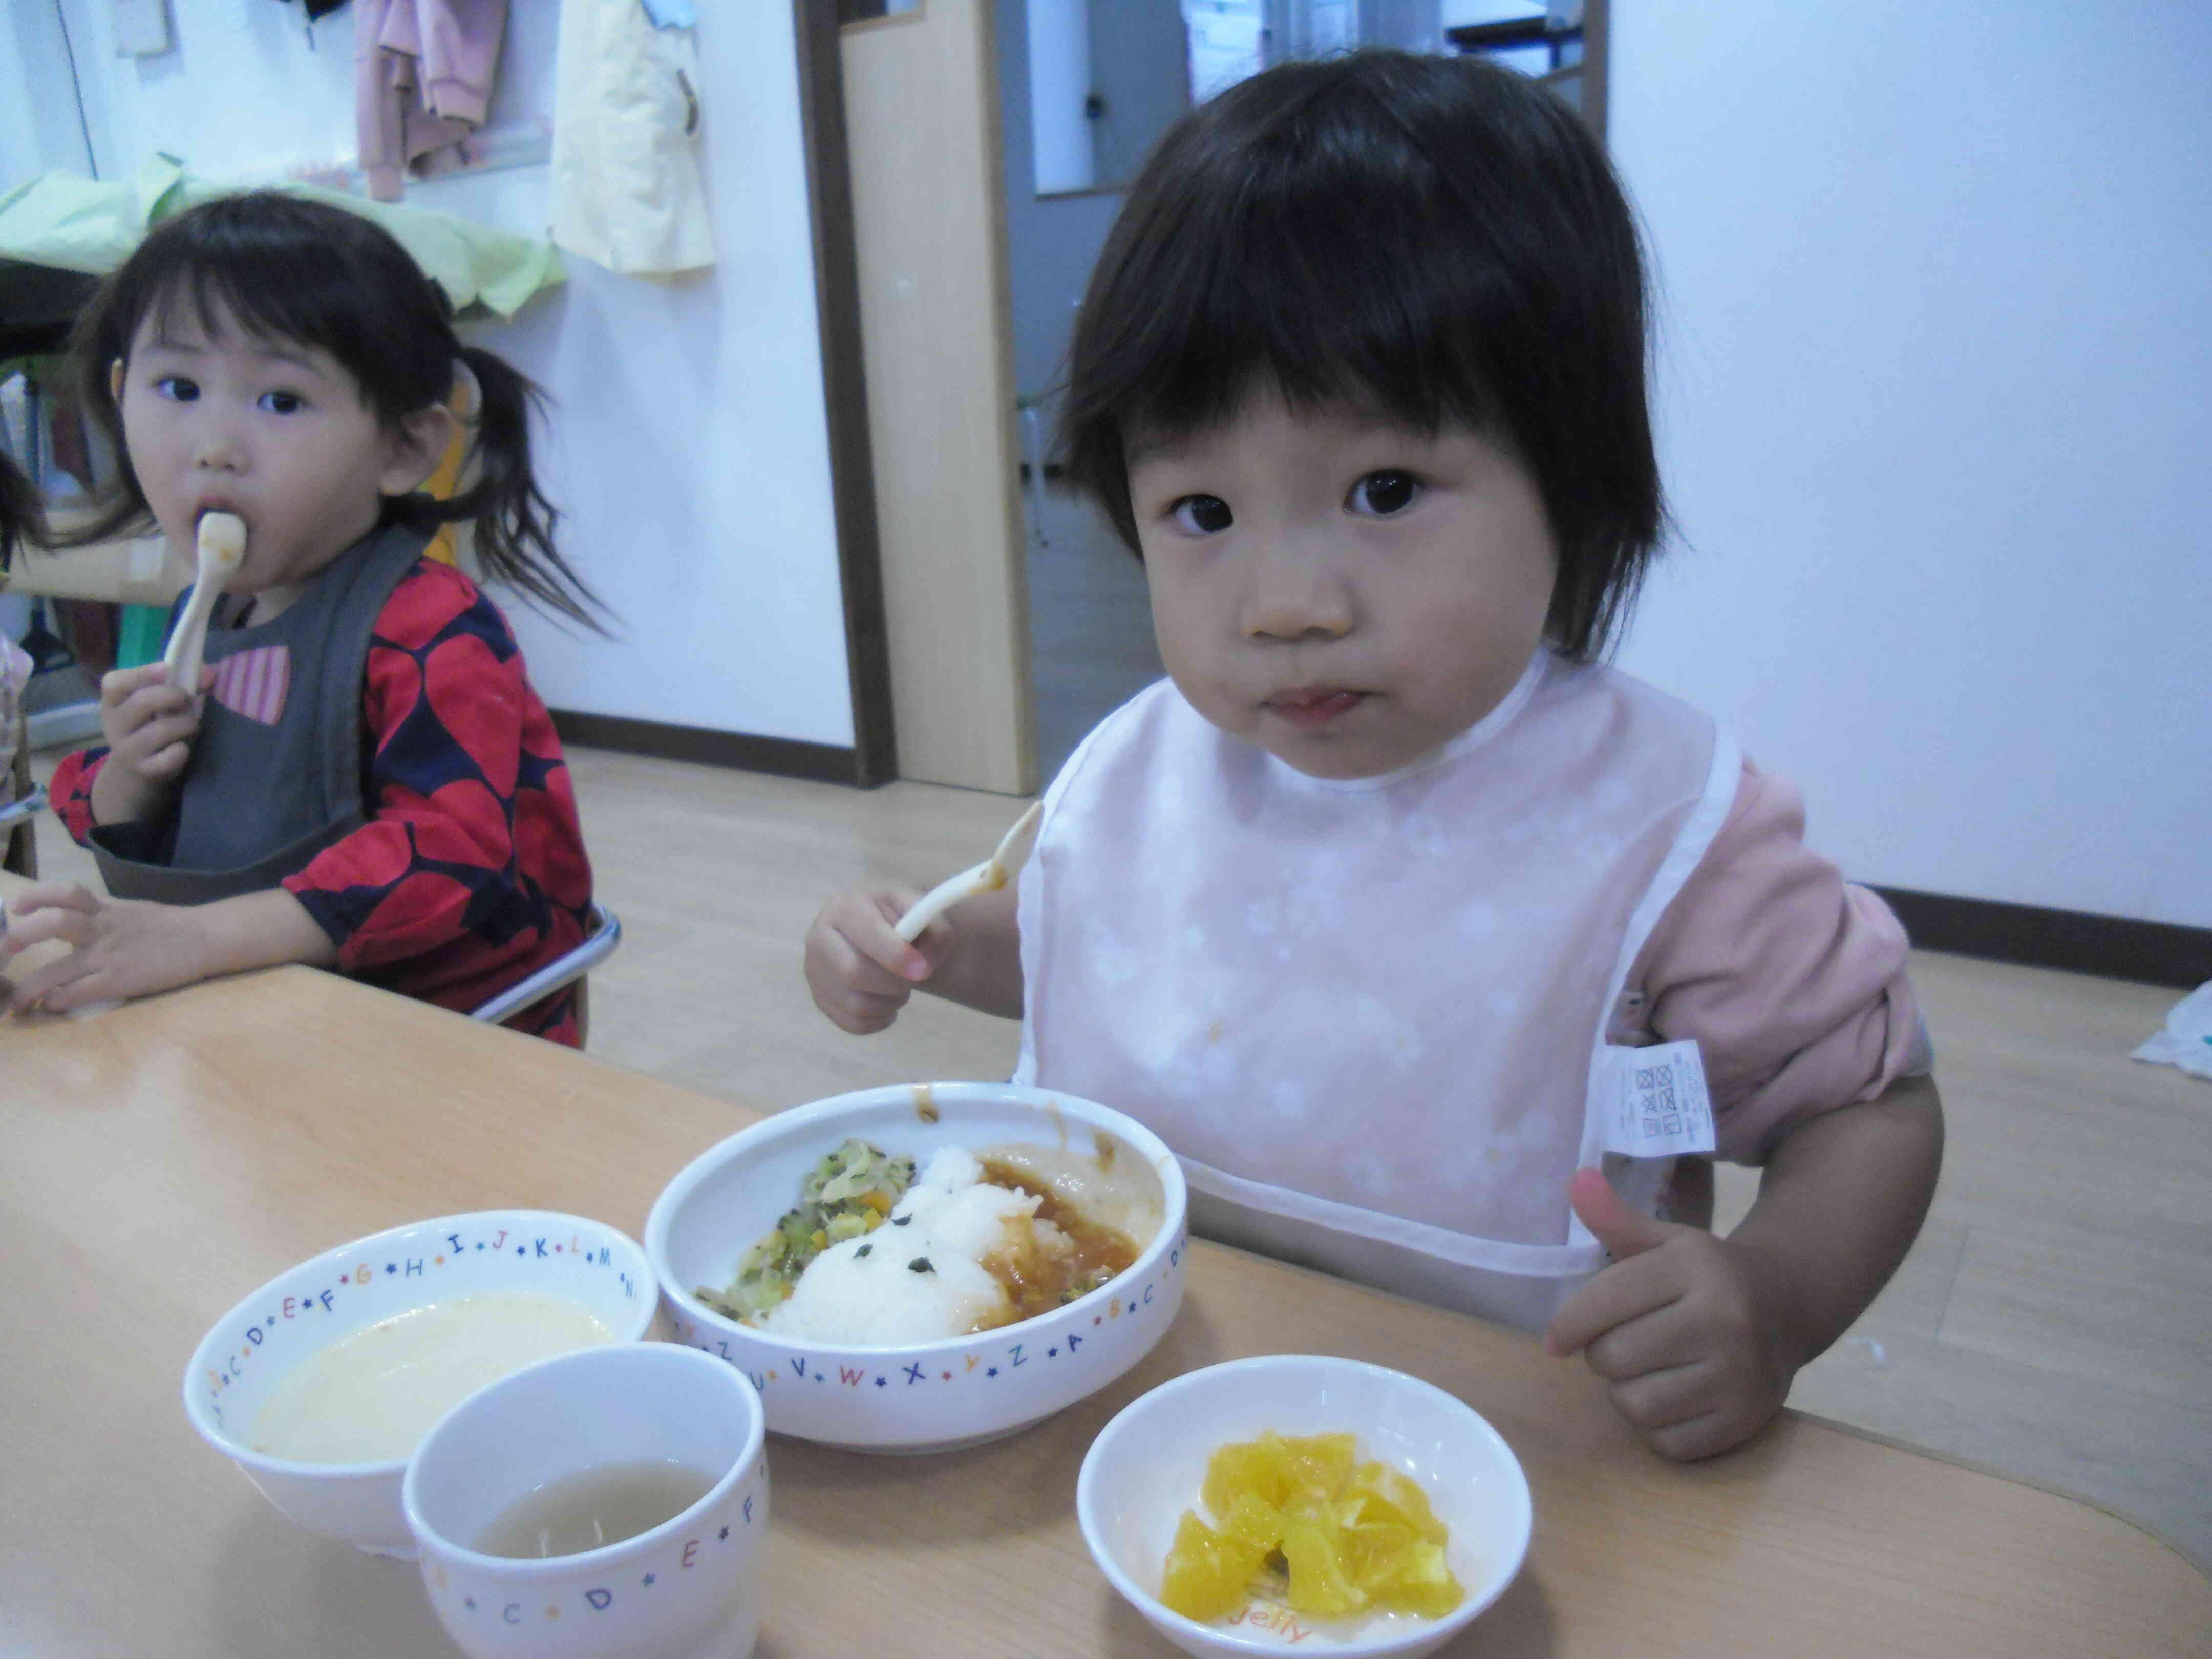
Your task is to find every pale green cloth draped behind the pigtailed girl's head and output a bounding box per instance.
[0,155,564,316]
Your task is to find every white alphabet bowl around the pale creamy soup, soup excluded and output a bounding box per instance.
[184,1210,655,1560]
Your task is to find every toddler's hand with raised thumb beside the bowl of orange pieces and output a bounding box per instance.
[1544,1170,1796,1462]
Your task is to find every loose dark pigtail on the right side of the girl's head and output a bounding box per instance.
[436,345,606,635]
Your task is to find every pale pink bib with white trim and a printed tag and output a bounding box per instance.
[1015,652,1741,1327]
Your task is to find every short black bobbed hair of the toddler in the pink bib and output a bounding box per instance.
[1059,51,1664,659]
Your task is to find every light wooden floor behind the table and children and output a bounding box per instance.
[22,750,2212,1564]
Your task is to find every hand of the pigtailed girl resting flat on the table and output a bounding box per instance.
[0,883,208,1013]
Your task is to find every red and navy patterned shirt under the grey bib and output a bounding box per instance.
[51,560,590,1046]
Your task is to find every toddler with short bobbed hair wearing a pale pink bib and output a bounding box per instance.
[807,53,1942,1458]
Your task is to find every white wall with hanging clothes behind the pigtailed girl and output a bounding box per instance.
[0,0,852,746]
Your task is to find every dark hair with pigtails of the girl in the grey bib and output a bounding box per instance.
[49,190,600,626]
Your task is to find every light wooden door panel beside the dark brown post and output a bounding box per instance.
[825,0,1035,794]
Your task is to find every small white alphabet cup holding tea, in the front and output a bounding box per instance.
[400,1343,768,1659]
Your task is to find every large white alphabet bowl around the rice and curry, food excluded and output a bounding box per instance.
[646,1084,1190,1451]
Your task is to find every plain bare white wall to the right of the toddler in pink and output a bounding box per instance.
[1610,0,2212,927]
